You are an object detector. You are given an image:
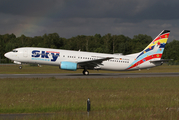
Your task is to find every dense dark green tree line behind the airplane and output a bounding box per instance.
[0,33,179,64]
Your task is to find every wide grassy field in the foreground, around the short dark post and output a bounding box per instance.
[0,77,179,120]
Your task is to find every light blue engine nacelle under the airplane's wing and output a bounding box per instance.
[59,61,77,71]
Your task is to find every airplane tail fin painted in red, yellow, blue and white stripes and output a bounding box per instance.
[128,30,170,69]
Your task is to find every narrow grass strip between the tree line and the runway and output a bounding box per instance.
[0,64,179,74]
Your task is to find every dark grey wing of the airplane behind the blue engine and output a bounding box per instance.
[77,57,113,69]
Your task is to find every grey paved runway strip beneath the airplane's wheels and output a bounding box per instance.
[0,73,179,78]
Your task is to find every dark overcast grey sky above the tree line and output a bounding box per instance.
[0,0,179,41]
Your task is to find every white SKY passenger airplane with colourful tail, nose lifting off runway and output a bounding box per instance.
[4,30,170,75]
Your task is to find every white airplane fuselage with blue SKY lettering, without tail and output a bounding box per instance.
[5,47,156,71]
